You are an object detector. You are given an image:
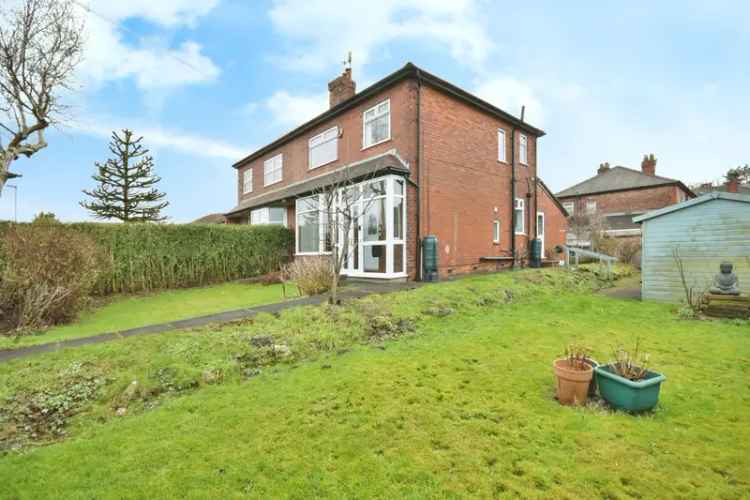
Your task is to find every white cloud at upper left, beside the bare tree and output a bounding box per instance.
[74,0,220,89]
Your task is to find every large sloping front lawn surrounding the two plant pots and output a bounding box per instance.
[0,271,750,499]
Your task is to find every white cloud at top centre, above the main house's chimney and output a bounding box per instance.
[270,0,495,71]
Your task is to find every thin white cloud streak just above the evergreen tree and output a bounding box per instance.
[72,117,247,161]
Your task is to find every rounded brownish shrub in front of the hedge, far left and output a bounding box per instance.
[0,224,102,328]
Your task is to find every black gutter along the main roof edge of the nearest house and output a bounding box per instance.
[232,63,545,168]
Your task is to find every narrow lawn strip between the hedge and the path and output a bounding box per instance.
[0,283,295,350]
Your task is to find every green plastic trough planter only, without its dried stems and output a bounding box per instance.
[594,365,667,413]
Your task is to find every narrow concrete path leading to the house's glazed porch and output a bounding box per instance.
[0,282,420,363]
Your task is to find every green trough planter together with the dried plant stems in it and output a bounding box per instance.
[595,340,667,413]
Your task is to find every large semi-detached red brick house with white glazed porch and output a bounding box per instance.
[226,63,566,279]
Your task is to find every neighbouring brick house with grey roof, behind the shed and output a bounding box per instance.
[557,154,695,244]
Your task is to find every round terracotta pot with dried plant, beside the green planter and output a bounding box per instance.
[552,344,594,405]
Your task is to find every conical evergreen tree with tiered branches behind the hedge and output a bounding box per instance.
[81,129,169,222]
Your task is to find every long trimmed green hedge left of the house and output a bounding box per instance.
[0,223,293,295]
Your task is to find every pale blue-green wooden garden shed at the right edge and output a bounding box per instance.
[633,192,750,302]
